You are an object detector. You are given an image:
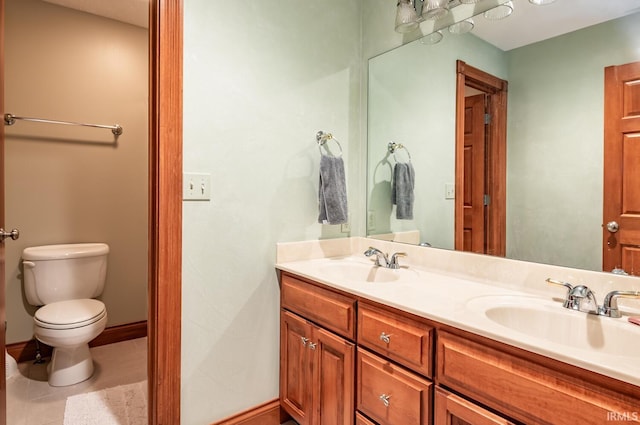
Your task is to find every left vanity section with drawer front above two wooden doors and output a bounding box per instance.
[280,274,355,425]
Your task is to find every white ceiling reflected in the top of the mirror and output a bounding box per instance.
[473,0,640,51]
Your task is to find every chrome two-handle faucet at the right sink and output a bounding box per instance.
[547,278,640,318]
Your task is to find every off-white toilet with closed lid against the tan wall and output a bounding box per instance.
[22,243,109,387]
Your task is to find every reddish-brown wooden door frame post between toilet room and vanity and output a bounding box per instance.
[147,0,183,425]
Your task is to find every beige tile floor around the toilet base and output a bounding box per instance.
[7,338,147,425]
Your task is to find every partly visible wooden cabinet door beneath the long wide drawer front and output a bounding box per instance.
[435,388,513,425]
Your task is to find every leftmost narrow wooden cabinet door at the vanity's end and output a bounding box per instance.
[280,311,313,425]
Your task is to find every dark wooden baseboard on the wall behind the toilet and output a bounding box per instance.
[7,320,147,363]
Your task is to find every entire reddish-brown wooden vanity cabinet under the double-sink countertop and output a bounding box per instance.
[280,272,640,425]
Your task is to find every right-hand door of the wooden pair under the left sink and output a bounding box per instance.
[310,328,355,425]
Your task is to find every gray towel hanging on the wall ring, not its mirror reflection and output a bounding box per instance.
[318,155,348,224]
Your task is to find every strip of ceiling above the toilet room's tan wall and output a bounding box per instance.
[43,0,149,28]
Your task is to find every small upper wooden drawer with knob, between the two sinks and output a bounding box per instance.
[358,303,433,378]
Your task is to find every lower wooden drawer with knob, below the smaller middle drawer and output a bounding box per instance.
[356,349,433,425]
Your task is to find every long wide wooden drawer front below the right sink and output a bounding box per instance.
[436,332,640,425]
